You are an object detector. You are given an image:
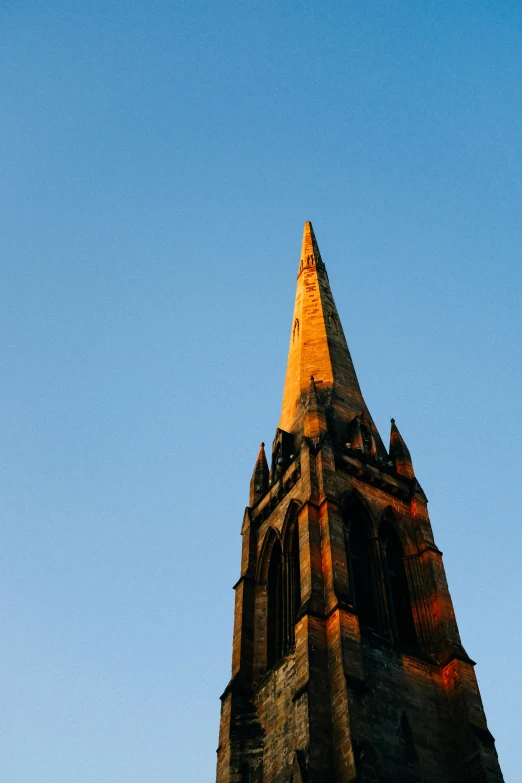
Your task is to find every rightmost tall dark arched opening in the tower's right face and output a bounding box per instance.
[379,521,417,644]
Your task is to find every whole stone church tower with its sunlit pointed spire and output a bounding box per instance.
[217,223,503,783]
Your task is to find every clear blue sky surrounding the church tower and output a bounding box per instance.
[0,0,522,783]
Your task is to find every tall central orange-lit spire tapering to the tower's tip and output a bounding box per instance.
[279,221,386,456]
